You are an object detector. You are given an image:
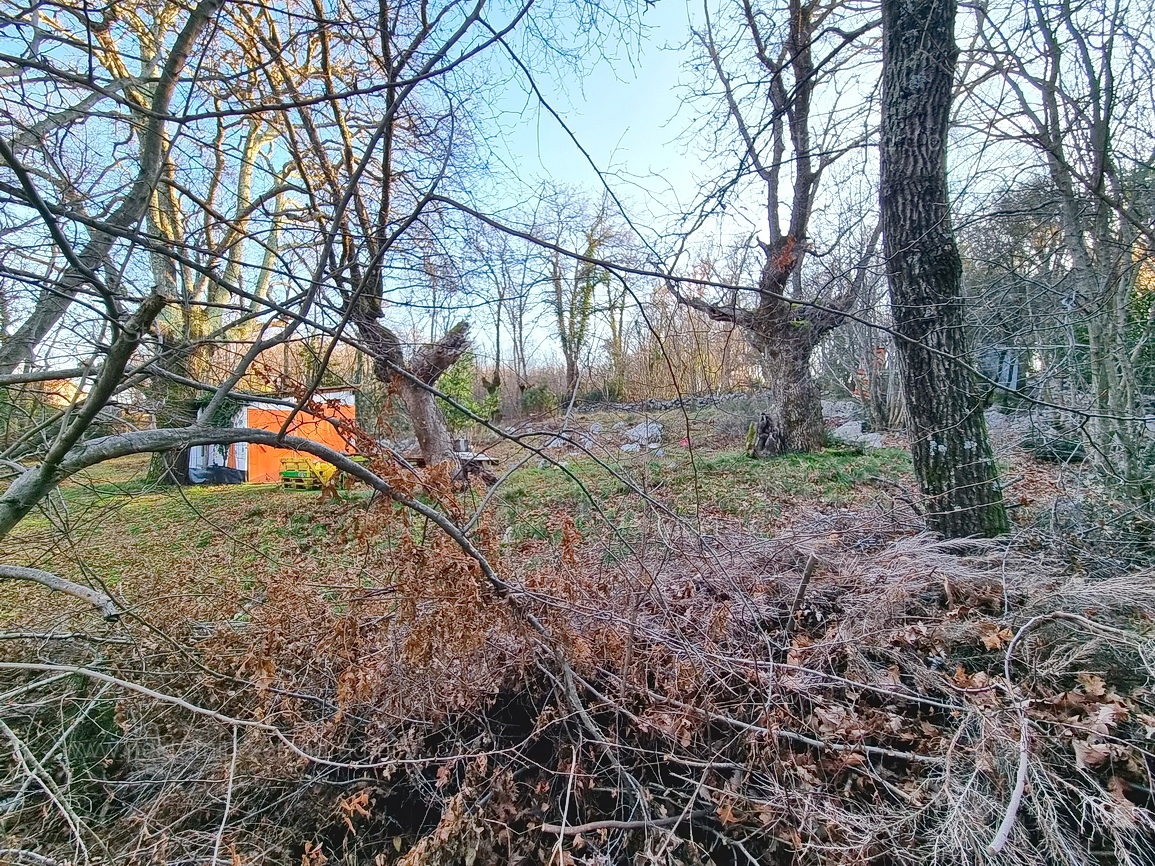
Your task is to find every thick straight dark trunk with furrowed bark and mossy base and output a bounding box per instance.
[881,0,1008,538]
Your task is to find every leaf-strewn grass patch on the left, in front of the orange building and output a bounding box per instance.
[0,480,381,626]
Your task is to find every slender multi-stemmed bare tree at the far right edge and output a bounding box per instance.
[968,0,1155,502]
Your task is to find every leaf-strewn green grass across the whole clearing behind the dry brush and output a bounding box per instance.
[0,436,910,622]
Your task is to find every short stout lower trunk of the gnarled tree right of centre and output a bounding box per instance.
[750,330,826,457]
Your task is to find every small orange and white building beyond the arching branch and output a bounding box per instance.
[188,390,357,484]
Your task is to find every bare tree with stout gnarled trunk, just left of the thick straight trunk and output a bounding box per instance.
[671,0,877,456]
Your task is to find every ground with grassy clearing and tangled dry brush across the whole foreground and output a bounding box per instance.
[0,443,1155,866]
